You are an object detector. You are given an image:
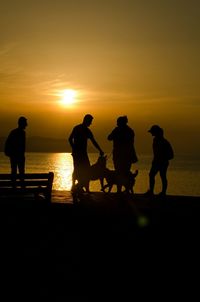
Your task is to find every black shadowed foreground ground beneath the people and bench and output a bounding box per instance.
[0,192,200,301]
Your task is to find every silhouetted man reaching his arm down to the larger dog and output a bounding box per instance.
[69,114,104,192]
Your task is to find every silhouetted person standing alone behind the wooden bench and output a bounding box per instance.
[5,116,27,186]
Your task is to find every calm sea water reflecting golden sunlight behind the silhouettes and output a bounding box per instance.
[0,152,200,196]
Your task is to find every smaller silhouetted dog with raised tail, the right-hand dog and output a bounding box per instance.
[102,168,138,194]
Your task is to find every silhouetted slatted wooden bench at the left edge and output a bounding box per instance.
[0,172,54,202]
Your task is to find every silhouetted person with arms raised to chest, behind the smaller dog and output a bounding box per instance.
[108,116,138,191]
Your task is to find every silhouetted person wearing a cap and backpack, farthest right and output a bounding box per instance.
[145,125,174,196]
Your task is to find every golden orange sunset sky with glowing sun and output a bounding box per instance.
[0,0,200,155]
